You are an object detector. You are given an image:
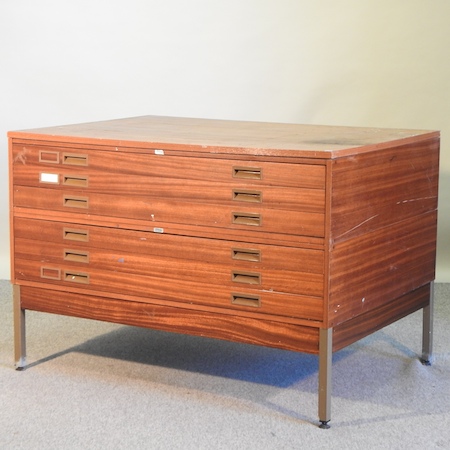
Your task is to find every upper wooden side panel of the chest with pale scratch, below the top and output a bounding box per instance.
[331,138,439,243]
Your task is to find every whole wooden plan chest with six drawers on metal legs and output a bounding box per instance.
[8,116,439,427]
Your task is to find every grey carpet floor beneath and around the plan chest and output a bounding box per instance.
[0,281,450,450]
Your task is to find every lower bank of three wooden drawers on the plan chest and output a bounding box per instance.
[14,218,323,320]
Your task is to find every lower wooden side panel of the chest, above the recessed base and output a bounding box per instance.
[329,211,437,326]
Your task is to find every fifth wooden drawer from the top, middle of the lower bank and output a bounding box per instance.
[15,239,323,297]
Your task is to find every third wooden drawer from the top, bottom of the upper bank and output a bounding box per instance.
[13,186,325,237]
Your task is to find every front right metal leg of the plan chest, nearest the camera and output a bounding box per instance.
[319,328,333,429]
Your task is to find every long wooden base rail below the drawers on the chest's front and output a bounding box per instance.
[21,286,319,354]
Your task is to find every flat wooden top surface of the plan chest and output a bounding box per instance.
[8,116,439,158]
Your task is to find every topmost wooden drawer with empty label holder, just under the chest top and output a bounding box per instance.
[13,144,325,190]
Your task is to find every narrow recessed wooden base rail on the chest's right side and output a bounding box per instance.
[333,284,430,351]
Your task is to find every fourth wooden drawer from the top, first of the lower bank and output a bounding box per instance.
[14,217,324,275]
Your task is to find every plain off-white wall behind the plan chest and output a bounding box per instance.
[0,0,450,282]
